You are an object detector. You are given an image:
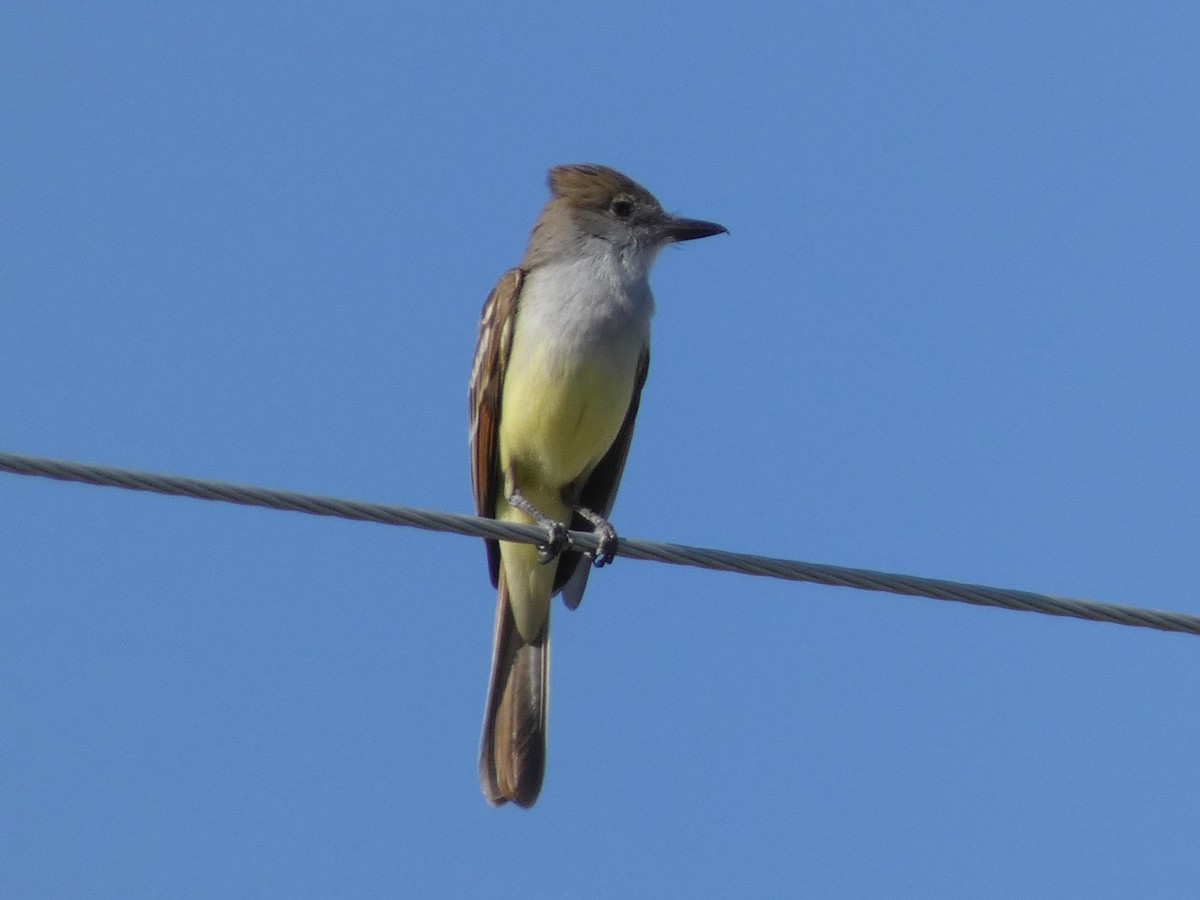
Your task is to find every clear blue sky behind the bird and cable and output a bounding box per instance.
[0,2,1200,898]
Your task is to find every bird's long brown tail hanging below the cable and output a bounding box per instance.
[479,565,550,808]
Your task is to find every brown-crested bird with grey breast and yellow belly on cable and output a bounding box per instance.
[469,164,727,808]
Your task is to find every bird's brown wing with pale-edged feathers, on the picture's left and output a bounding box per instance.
[468,269,526,586]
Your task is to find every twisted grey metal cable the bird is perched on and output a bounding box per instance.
[0,452,1200,635]
